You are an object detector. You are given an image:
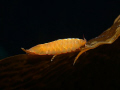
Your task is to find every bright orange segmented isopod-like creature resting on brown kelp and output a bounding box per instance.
[21,38,86,63]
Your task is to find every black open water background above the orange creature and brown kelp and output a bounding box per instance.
[0,0,120,59]
